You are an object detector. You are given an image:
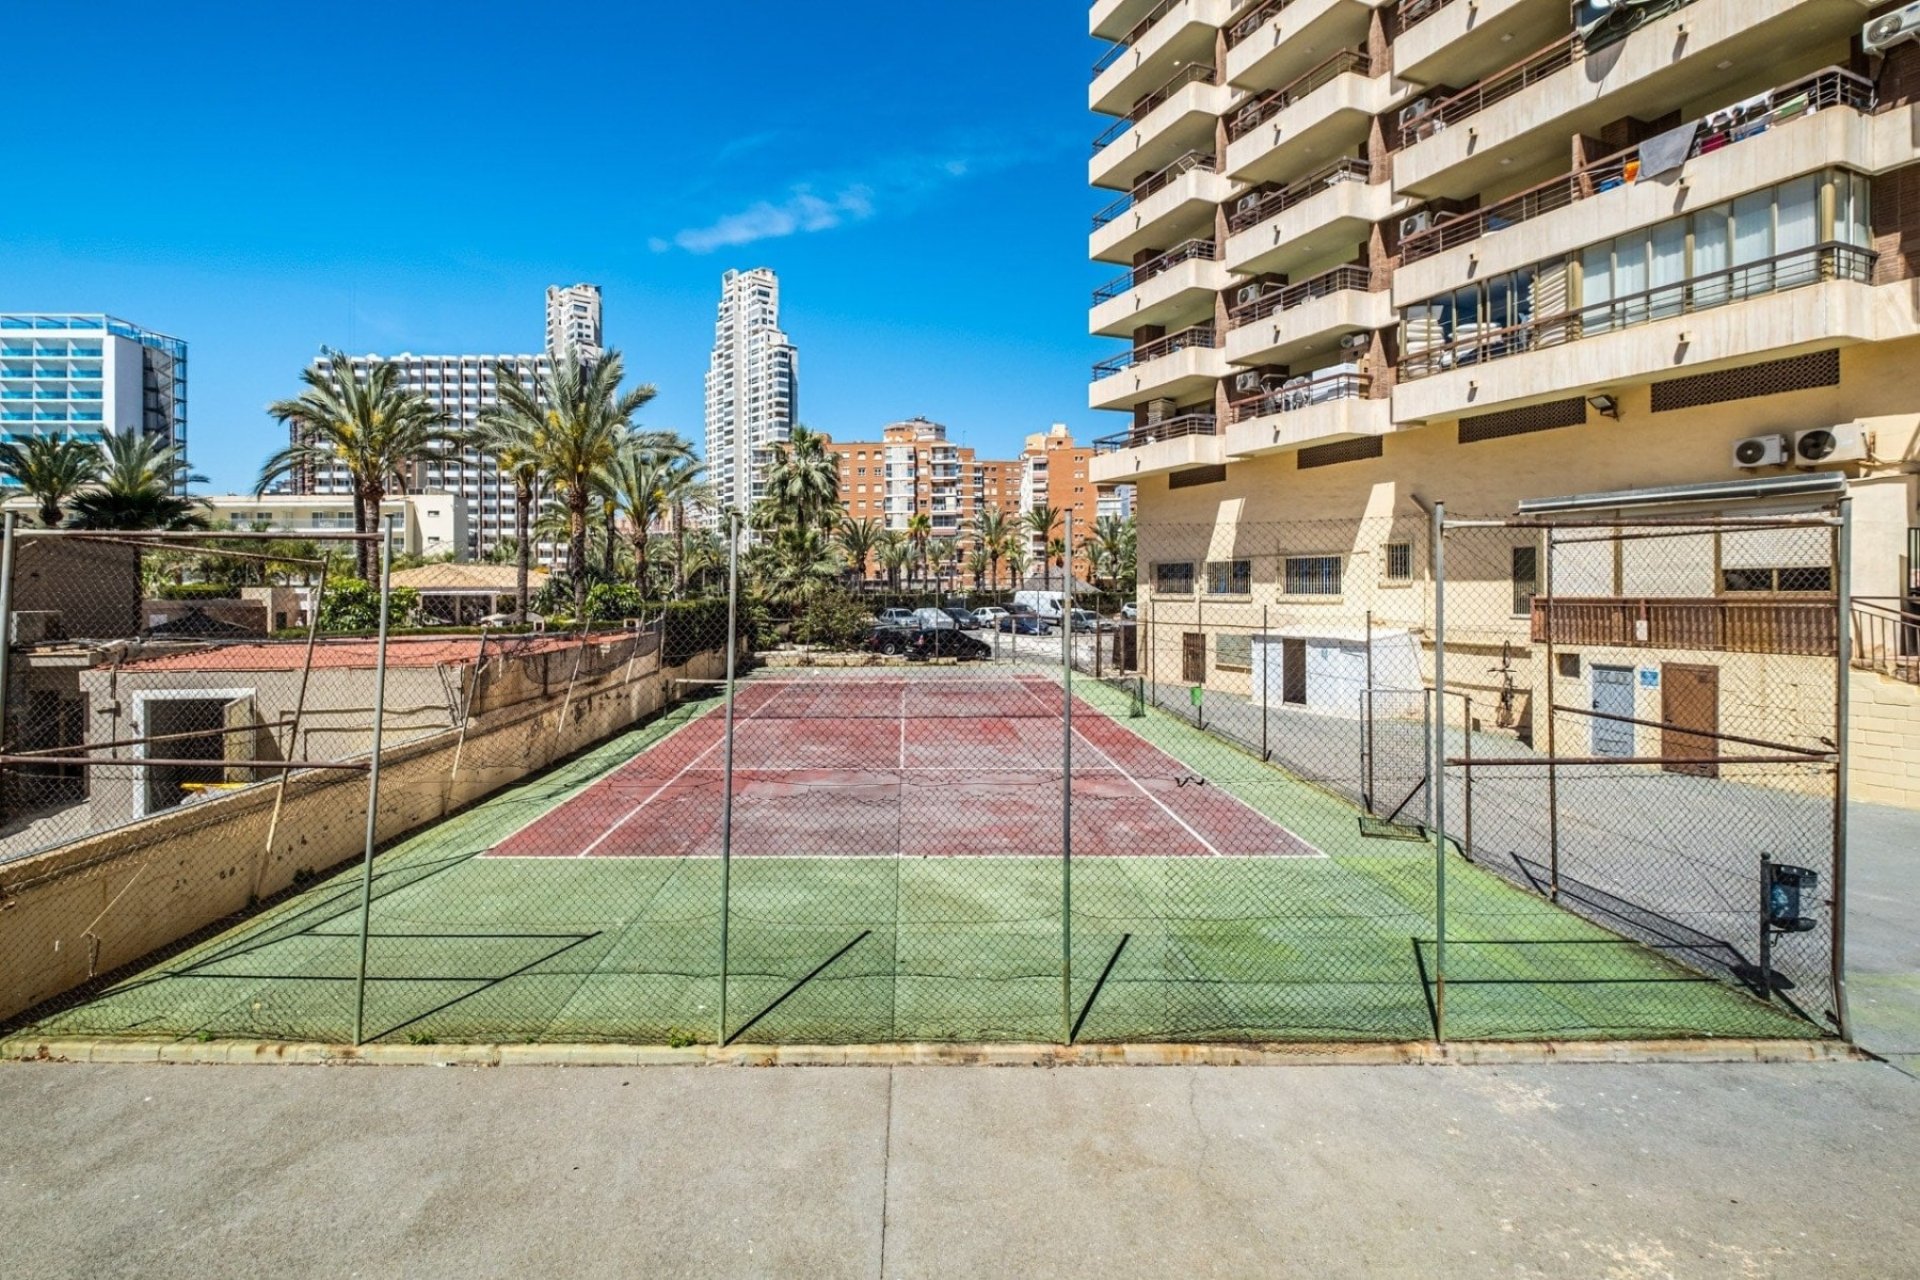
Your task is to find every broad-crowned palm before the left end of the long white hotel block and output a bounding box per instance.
[255,351,459,580]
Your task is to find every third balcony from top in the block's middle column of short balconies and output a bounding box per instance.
[1227,157,1394,276]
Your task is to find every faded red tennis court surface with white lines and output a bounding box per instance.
[488,677,1319,858]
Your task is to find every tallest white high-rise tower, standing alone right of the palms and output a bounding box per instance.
[707,267,799,510]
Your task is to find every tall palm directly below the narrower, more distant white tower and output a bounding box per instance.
[495,349,655,618]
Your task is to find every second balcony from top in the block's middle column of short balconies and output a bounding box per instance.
[1227,50,1392,182]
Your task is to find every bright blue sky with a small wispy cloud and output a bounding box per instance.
[0,0,1114,491]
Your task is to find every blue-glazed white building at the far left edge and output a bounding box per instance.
[0,313,186,485]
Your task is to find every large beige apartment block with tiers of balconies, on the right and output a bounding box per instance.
[1089,0,1920,804]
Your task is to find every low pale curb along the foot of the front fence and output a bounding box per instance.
[0,1036,1874,1067]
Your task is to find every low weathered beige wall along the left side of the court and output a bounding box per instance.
[0,645,726,1019]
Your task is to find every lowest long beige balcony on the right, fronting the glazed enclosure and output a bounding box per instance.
[1394,244,1889,422]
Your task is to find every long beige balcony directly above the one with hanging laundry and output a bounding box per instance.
[1394,0,1859,198]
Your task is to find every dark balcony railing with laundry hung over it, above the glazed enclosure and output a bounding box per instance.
[1400,67,1874,263]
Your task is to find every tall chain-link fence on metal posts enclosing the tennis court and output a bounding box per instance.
[0,514,1845,1044]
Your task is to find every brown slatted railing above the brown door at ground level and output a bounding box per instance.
[1532,595,1839,658]
